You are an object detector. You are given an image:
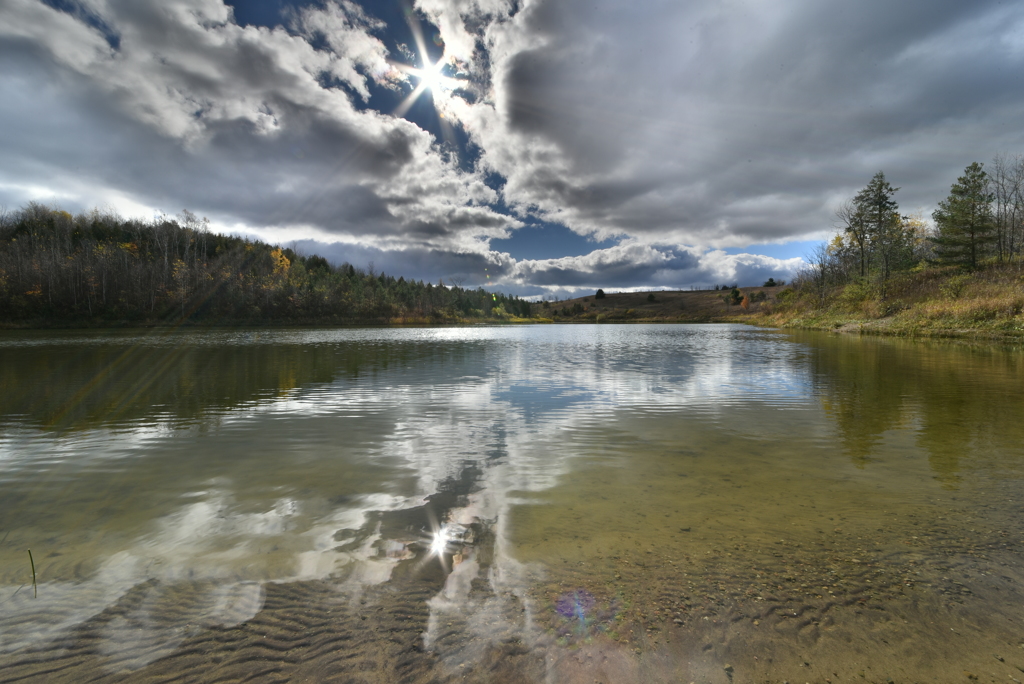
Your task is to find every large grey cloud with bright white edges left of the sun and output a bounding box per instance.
[0,0,519,249]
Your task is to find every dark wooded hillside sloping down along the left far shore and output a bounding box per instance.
[0,203,530,325]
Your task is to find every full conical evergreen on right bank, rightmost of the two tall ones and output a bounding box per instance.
[932,162,995,268]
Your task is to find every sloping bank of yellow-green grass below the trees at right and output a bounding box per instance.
[746,262,1024,339]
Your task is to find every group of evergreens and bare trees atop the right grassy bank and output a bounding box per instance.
[799,156,1024,297]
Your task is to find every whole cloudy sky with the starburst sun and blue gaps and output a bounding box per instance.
[0,0,1024,298]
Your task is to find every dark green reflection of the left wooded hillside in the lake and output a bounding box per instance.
[0,333,479,430]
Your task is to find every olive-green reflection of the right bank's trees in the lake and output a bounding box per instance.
[803,336,1024,486]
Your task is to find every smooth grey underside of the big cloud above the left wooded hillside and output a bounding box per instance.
[0,61,407,237]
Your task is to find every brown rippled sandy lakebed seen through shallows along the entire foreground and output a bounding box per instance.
[0,491,1024,682]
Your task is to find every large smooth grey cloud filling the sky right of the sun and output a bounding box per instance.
[453,0,1024,245]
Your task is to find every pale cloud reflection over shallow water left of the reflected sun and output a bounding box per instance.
[0,482,419,670]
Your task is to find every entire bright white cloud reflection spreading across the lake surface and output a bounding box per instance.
[0,327,809,669]
